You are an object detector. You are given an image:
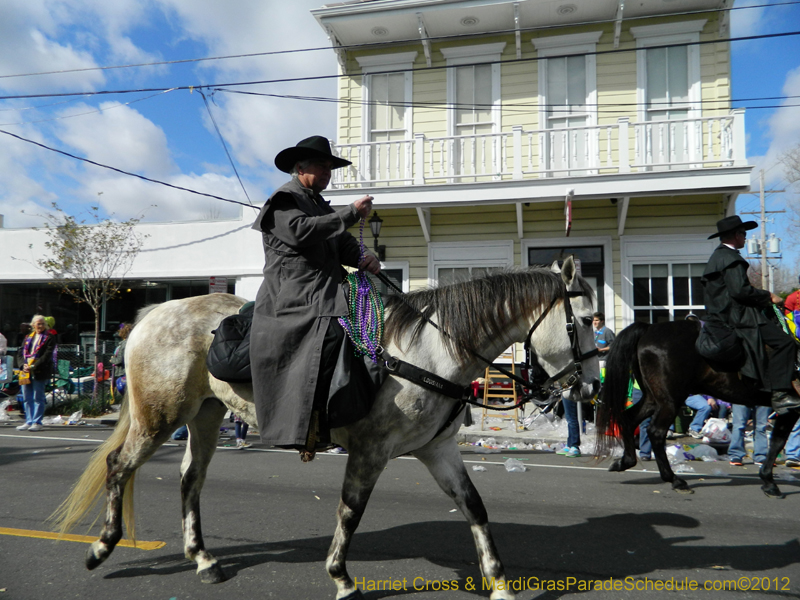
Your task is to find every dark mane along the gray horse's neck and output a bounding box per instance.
[384,268,594,363]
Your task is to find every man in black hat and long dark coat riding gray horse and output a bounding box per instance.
[250,136,380,456]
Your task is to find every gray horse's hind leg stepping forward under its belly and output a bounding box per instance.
[181,398,227,583]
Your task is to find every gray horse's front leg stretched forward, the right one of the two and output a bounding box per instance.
[414,438,514,600]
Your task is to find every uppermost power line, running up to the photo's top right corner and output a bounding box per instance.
[0,0,800,79]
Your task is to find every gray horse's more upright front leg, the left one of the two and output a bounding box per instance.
[326,446,389,600]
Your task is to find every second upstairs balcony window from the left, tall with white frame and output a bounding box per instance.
[442,42,506,181]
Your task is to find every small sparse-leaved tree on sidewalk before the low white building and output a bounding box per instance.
[30,203,148,393]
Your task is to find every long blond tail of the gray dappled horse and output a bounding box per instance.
[48,395,135,539]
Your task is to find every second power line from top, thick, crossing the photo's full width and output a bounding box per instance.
[0,31,800,100]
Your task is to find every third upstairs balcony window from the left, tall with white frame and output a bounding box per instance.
[533,32,601,177]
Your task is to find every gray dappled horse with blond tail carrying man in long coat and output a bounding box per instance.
[54,257,599,600]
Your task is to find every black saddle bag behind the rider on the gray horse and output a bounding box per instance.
[206,302,254,383]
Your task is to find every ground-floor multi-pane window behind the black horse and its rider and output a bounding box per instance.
[632,262,706,323]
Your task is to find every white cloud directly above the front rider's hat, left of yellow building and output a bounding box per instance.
[155,0,337,169]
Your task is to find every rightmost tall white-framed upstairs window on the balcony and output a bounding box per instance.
[631,20,706,168]
